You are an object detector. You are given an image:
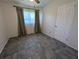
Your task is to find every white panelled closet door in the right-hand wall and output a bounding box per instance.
[54,3,74,42]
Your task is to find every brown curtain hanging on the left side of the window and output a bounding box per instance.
[16,7,26,36]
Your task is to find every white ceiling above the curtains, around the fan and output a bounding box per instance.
[0,0,52,8]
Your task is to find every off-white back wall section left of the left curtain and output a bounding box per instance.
[1,3,18,38]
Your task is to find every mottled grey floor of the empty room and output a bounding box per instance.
[0,33,77,59]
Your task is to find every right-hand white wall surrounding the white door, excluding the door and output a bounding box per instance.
[42,0,78,50]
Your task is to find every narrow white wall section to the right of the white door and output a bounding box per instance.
[66,4,78,49]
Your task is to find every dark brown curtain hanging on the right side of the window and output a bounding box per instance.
[35,10,41,33]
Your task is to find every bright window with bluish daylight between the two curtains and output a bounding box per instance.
[24,9,35,24]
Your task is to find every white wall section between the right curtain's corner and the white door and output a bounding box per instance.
[43,4,56,37]
